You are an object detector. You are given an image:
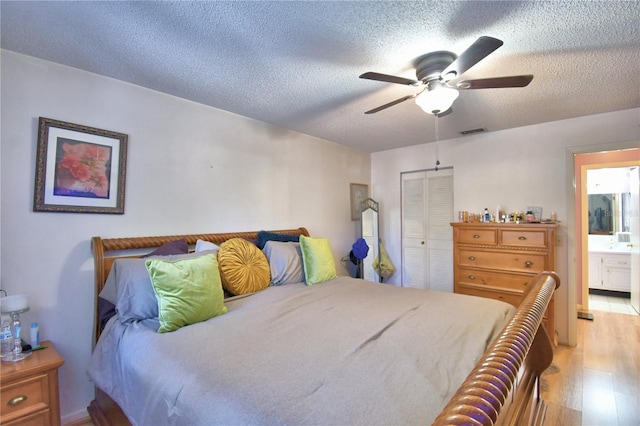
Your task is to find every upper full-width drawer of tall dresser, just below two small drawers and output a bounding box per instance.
[457,249,548,274]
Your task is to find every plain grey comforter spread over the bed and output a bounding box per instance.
[88,277,514,426]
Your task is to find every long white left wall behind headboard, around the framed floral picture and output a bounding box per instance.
[0,50,370,421]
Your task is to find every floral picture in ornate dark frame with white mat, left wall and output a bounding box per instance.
[33,117,127,214]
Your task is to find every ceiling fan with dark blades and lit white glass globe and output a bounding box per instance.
[360,36,533,116]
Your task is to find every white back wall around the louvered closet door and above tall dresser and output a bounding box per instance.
[371,109,640,343]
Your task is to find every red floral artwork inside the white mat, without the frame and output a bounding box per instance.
[53,138,111,198]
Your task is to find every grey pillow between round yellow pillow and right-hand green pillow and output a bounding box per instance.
[262,241,304,285]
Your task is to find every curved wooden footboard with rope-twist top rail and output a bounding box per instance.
[434,272,560,425]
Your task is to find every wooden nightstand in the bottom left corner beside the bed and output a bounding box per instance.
[0,341,64,426]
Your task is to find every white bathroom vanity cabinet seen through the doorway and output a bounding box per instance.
[589,253,631,292]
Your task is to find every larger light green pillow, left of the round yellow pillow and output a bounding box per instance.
[145,254,227,333]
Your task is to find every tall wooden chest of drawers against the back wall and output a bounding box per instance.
[451,222,557,344]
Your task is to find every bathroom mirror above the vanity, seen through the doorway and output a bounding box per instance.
[589,192,631,235]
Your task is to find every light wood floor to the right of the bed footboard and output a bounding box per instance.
[542,311,640,426]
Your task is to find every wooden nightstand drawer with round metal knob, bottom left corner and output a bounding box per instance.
[0,374,49,424]
